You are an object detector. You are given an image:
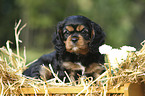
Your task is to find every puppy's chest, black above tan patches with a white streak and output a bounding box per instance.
[62,55,102,75]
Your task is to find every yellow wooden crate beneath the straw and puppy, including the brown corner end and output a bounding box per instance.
[22,83,145,96]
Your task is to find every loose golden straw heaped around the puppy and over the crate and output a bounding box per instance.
[0,20,145,96]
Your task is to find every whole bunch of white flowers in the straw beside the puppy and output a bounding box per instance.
[99,44,136,68]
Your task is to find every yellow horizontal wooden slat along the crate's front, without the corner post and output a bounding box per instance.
[22,87,124,94]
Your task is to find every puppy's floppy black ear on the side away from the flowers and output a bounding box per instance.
[53,21,65,53]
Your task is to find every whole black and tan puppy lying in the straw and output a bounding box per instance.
[23,16,105,80]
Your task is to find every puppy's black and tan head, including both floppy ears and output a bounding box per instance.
[53,16,104,55]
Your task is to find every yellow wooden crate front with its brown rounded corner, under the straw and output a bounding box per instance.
[13,83,145,96]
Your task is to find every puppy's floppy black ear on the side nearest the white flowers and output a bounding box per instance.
[89,22,105,53]
